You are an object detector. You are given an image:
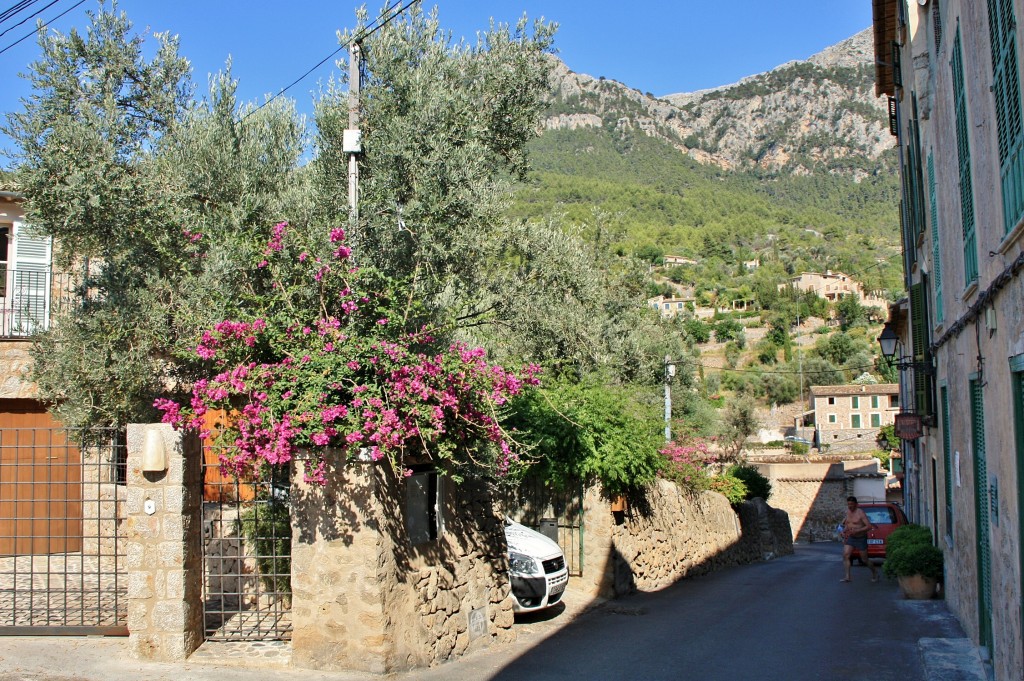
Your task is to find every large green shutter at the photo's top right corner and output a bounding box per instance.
[988,0,1024,231]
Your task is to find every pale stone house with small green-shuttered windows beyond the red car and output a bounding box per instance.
[811,383,899,452]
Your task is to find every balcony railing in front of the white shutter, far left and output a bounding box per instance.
[0,264,77,339]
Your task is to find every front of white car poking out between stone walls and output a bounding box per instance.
[505,516,569,612]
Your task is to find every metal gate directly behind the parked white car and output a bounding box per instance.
[505,479,584,577]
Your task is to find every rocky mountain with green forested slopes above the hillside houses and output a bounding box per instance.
[513,31,901,292]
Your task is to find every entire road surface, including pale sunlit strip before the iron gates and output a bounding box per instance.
[0,544,988,681]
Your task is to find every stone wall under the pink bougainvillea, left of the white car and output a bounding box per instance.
[292,454,514,674]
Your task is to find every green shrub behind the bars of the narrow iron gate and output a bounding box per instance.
[240,498,292,594]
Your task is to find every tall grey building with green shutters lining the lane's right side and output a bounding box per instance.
[872,0,1024,681]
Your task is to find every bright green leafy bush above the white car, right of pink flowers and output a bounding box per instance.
[508,376,662,498]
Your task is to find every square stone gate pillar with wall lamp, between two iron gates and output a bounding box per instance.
[125,424,203,661]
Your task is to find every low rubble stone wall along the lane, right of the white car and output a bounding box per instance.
[574,480,793,598]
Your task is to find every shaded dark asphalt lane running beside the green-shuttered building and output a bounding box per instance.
[402,544,985,681]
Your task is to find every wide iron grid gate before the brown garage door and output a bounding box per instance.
[0,427,128,636]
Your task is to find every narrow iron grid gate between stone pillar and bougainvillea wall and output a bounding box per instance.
[203,449,292,641]
